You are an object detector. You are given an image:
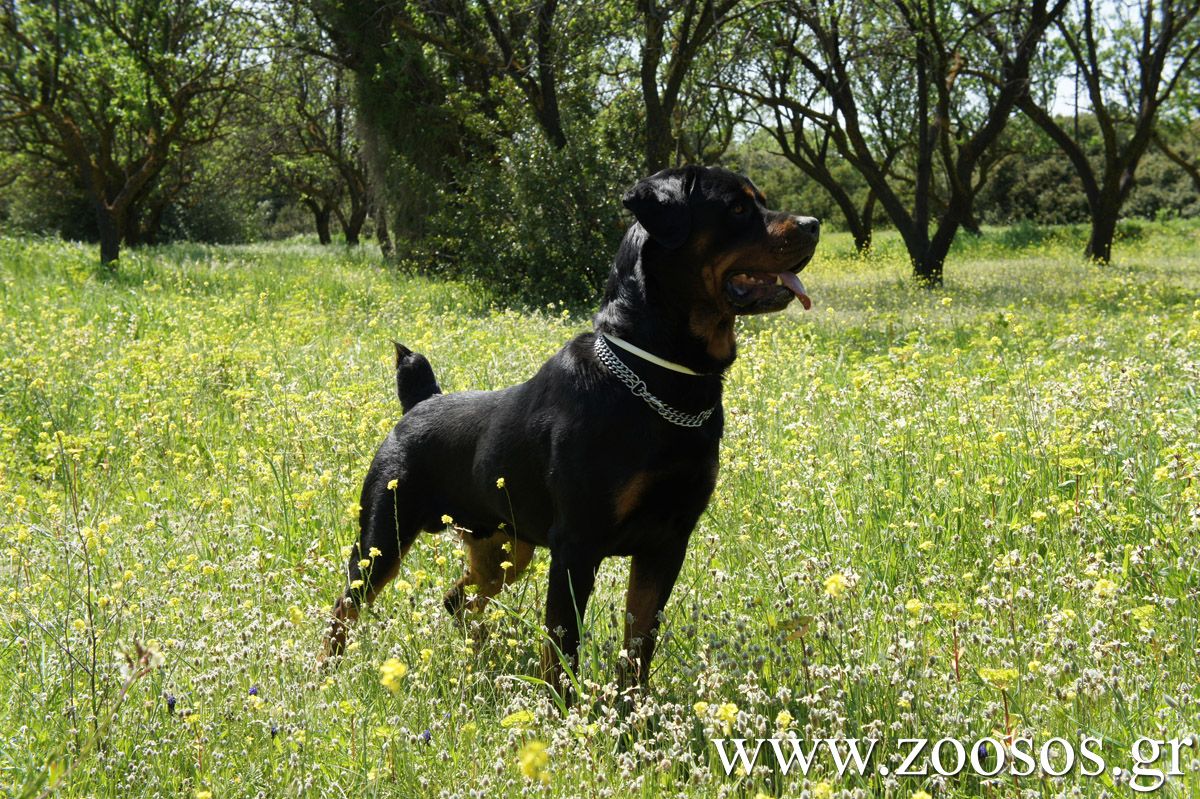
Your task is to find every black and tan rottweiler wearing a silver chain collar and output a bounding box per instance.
[326,167,820,685]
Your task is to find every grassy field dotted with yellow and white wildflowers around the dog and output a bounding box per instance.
[7,226,1200,799]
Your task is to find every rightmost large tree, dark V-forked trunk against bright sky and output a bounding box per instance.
[1019,0,1200,263]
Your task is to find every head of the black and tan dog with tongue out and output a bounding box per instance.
[624,167,821,360]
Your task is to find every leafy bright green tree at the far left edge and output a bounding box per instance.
[0,0,251,264]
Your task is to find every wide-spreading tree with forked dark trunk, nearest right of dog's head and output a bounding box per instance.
[734,0,1067,286]
